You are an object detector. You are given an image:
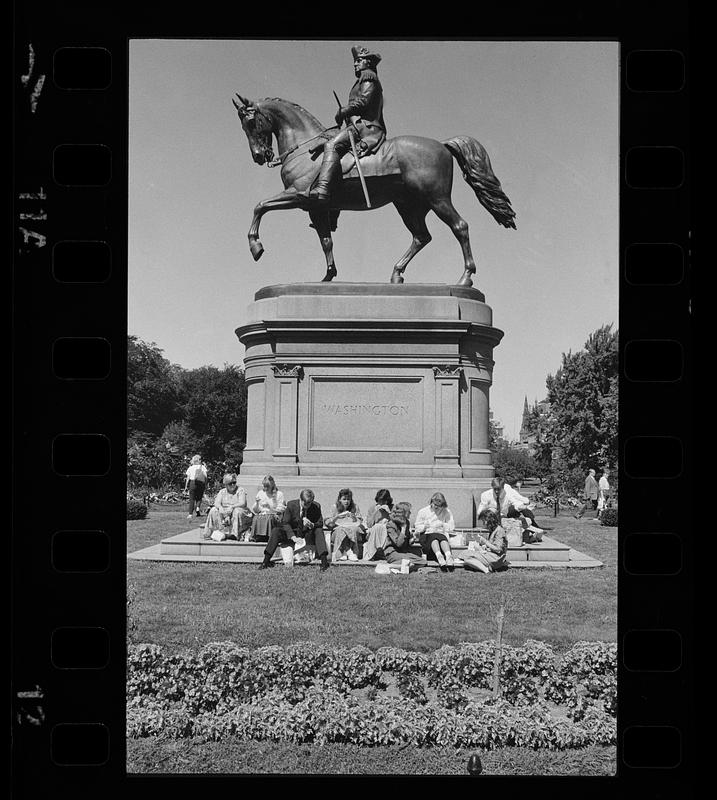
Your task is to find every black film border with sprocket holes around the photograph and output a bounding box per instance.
[11,2,695,797]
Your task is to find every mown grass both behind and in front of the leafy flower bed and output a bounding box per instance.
[127,504,617,775]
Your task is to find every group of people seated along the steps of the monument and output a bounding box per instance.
[203,473,543,572]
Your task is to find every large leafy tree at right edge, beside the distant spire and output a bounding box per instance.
[536,325,618,482]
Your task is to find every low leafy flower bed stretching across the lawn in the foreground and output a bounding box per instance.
[127,640,616,749]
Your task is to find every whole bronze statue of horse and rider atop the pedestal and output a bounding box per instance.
[232,47,515,286]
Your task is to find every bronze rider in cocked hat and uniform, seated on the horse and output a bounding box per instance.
[309,47,386,202]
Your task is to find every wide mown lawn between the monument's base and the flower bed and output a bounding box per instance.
[127,504,617,652]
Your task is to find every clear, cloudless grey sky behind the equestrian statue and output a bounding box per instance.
[128,39,619,438]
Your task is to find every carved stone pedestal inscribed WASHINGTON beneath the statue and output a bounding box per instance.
[236,282,503,527]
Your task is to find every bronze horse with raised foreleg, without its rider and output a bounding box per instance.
[232,94,515,286]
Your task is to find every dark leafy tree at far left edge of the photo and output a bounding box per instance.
[127,336,181,436]
